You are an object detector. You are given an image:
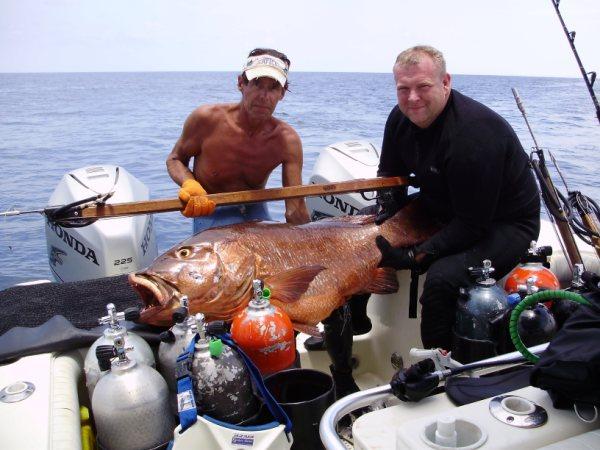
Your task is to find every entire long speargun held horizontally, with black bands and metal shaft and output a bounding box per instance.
[0,177,411,227]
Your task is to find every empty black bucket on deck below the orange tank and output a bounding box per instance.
[265,369,335,449]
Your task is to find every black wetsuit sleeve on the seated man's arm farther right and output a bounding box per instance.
[417,130,509,257]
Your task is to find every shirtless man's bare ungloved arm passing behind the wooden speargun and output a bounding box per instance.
[282,129,310,225]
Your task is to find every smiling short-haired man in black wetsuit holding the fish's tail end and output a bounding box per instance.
[377,46,540,350]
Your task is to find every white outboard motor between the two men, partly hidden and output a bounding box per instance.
[306,141,380,220]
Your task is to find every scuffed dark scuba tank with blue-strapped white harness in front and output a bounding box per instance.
[169,314,294,450]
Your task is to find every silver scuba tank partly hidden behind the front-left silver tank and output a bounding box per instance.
[83,303,156,399]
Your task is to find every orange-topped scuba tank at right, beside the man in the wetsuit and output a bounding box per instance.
[504,241,560,294]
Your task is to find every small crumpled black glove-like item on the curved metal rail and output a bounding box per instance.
[390,358,440,402]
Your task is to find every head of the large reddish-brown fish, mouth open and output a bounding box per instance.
[129,238,254,326]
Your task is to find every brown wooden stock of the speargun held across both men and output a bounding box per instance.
[72,177,409,219]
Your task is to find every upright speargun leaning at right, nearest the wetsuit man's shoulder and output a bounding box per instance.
[512,88,583,271]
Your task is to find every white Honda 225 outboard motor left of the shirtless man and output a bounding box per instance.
[45,165,158,281]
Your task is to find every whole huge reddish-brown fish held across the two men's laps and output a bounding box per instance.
[129,202,438,332]
